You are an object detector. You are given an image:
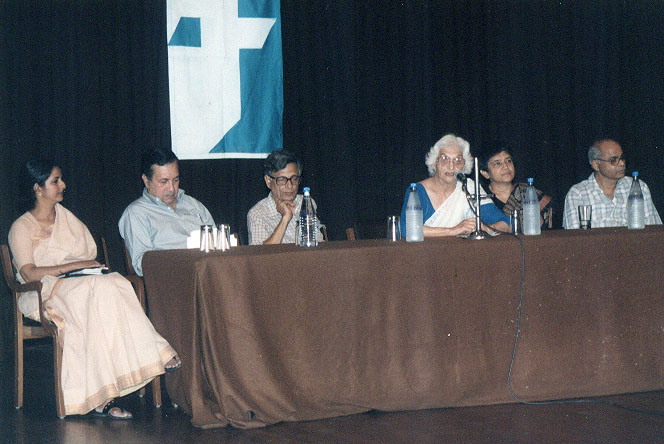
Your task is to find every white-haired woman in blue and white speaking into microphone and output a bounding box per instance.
[401,134,509,237]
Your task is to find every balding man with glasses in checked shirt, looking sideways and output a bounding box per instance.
[563,139,662,228]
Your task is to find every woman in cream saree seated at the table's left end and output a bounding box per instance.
[9,161,180,419]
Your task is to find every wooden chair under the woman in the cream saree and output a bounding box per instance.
[0,244,65,419]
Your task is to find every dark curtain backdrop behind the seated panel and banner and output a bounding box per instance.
[0,0,664,362]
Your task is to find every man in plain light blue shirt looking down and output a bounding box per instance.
[118,149,214,276]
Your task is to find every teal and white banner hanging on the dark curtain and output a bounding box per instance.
[166,0,284,159]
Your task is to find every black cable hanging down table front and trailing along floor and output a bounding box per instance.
[505,233,664,417]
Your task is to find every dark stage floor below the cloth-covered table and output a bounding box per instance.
[0,338,664,444]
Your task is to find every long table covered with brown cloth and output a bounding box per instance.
[143,226,664,428]
